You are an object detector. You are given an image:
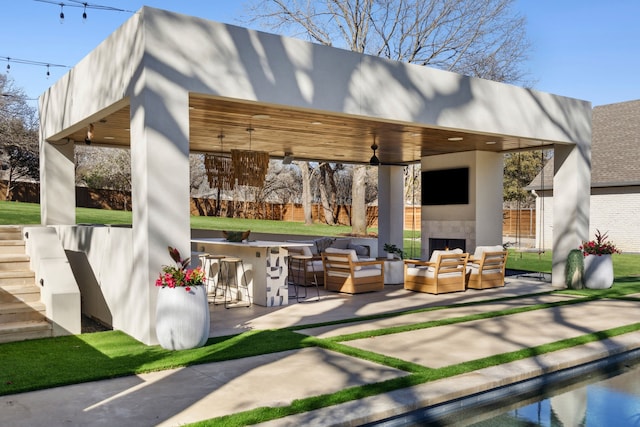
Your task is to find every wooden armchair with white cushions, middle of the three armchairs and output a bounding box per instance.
[404,249,469,294]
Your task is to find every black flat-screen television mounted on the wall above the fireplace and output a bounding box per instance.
[422,168,469,206]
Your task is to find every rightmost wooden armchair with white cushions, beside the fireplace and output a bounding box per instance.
[467,245,509,289]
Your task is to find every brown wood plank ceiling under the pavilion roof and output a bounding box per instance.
[65,95,550,164]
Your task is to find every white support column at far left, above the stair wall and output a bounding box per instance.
[40,135,76,225]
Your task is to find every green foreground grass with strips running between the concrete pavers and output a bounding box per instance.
[0,290,640,426]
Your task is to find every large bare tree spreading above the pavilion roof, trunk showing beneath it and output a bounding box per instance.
[245,0,530,232]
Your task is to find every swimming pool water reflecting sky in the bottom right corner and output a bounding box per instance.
[368,350,640,427]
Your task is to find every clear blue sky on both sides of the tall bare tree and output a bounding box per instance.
[0,0,640,106]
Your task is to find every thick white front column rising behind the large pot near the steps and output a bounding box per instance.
[129,82,191,344]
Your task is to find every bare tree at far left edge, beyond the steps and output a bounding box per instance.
[0,74,40,200]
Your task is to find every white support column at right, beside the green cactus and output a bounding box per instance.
[551,141,591,288]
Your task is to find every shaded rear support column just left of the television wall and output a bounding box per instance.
[378,166,404,256]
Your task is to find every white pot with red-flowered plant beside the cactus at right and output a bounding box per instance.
[580,230,620,289]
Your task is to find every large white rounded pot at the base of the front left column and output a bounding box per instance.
[156,286,210,350]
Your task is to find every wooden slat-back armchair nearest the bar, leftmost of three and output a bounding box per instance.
[322,248,384,294]
